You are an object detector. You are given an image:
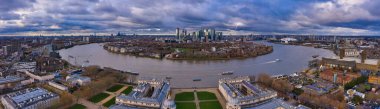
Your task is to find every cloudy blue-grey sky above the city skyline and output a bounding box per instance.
[0,0,380,35]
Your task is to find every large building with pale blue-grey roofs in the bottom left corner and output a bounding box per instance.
[1,88,59,109]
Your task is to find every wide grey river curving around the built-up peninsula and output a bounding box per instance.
[59,41,335,88]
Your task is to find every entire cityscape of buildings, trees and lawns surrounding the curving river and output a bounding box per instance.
[0,28,380,109]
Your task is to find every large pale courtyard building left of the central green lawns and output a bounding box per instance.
[111,79,170,109]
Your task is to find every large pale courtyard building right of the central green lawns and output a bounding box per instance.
[219,76,277,109]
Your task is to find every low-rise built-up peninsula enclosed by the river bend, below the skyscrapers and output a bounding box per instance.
[103,42,273,60]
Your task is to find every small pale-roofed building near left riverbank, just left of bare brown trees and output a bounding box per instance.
[66,74,91,86]
